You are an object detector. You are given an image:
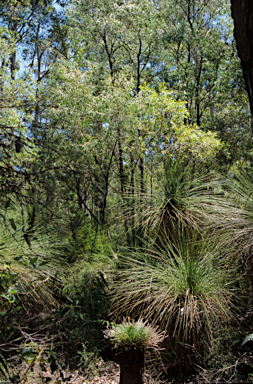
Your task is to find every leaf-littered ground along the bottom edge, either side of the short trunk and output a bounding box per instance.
[5,349,253,384]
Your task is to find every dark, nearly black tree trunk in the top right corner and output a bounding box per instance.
[231,0,253,116]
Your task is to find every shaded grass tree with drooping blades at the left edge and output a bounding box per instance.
[0,202,62,307]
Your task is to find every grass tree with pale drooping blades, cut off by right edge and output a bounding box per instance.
[208,167,253,286]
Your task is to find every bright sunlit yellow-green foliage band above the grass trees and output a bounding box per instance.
[47,62,221,166]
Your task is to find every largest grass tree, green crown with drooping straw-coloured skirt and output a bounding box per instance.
[110,229,235,362]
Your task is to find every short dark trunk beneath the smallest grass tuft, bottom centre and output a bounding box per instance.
[116,349,144,384]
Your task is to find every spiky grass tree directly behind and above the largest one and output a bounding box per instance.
[125,158,217,247]
